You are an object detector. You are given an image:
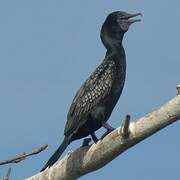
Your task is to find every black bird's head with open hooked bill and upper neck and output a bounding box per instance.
[101,11,142,47]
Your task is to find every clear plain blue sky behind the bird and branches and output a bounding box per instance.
[0,0,180,180]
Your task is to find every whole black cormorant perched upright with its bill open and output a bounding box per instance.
[41,11,141,171]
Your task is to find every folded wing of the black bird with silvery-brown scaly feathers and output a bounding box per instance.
[64,61,115,134]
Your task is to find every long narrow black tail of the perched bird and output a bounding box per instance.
[41,137,70,172]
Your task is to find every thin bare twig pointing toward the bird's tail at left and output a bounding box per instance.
[0,144,48,165]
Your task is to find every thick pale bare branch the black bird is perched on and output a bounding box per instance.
[26,91,180,180]
